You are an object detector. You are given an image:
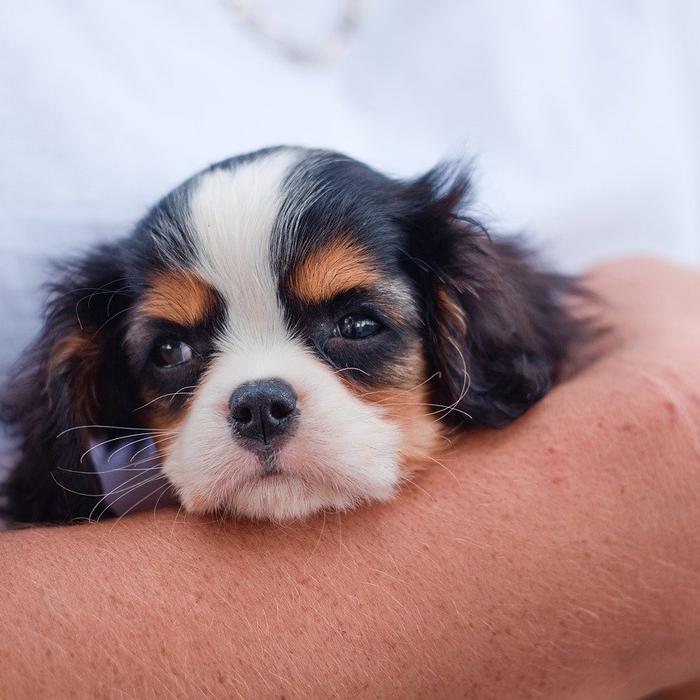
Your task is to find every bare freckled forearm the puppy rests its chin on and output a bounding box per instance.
[0,260,700,698]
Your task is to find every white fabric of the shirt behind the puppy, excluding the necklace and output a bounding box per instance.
[0,0,700,388]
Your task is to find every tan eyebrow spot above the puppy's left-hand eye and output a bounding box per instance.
[139,270,216,326]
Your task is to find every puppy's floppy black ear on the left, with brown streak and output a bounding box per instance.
[2,247,133,522]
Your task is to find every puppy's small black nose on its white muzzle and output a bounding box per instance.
[229,379,297,447]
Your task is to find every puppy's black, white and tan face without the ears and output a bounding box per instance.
[126,150,437,519]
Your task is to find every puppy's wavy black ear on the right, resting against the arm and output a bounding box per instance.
[400,168,585,426]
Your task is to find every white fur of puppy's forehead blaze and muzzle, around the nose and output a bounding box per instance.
[156,150,402,520]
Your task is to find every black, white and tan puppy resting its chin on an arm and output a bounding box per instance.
[4,147,583,522]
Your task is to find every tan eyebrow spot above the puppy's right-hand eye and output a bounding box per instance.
[289,238,380,303]
